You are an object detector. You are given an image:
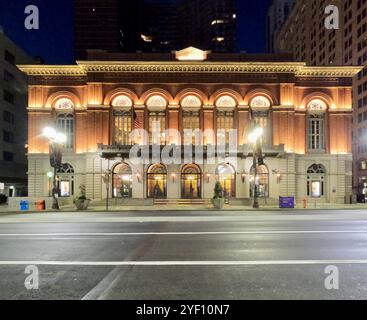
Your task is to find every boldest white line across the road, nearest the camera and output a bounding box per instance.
[0,259,367,266]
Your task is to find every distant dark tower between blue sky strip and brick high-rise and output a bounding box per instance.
[266,0,296,53]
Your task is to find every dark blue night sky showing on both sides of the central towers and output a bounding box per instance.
[0,0,270,64]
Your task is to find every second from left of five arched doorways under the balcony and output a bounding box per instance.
[147,164,167,199]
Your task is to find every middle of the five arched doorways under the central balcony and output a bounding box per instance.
[181,164,201,199]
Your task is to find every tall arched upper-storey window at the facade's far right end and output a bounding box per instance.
[307,99,327,151]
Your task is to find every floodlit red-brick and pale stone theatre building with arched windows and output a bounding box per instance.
[19,48,360,204]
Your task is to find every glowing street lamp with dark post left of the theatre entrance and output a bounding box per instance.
[42,127,67,210]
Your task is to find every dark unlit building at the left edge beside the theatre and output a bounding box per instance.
[0,27,32,197]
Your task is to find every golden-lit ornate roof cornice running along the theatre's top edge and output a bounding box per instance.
[18,61,362,78]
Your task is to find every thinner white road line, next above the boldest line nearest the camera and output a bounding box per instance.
[0,230,367,238]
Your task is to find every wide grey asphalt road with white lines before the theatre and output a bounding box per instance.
[0,211,367,300]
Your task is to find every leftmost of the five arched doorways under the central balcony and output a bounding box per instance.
[112,163,133,198]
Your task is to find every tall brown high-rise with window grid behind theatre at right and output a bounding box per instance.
[277,0,367,193]
